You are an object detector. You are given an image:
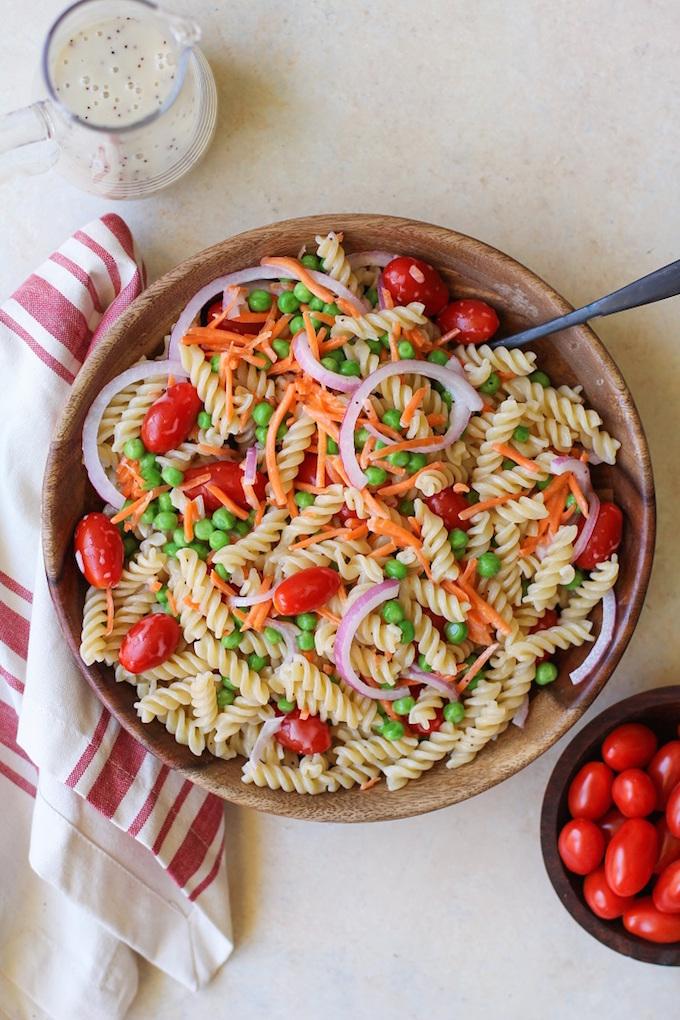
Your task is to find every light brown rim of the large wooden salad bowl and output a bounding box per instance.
[42,213,656,821]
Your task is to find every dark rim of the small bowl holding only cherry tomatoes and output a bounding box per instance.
[540,683,680,967]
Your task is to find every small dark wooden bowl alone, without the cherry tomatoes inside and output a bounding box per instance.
[540,685,680,967]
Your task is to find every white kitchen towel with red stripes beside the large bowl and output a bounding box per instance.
[0,214,232,1020]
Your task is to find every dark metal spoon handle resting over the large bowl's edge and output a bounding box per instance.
[490,260,680,348]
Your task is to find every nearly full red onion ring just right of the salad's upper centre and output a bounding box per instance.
[339,359,482,489]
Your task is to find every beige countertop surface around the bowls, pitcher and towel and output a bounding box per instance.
[0,0,680,1020]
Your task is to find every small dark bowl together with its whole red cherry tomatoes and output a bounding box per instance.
[540,685,680,967]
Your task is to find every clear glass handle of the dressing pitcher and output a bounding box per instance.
[0,102,58,182]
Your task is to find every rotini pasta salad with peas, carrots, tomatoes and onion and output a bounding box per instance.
[75,232,622,794]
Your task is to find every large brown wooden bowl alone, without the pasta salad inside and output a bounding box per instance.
[43,214,655,822]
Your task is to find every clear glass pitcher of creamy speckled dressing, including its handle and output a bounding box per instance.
[0,0,217,199]
